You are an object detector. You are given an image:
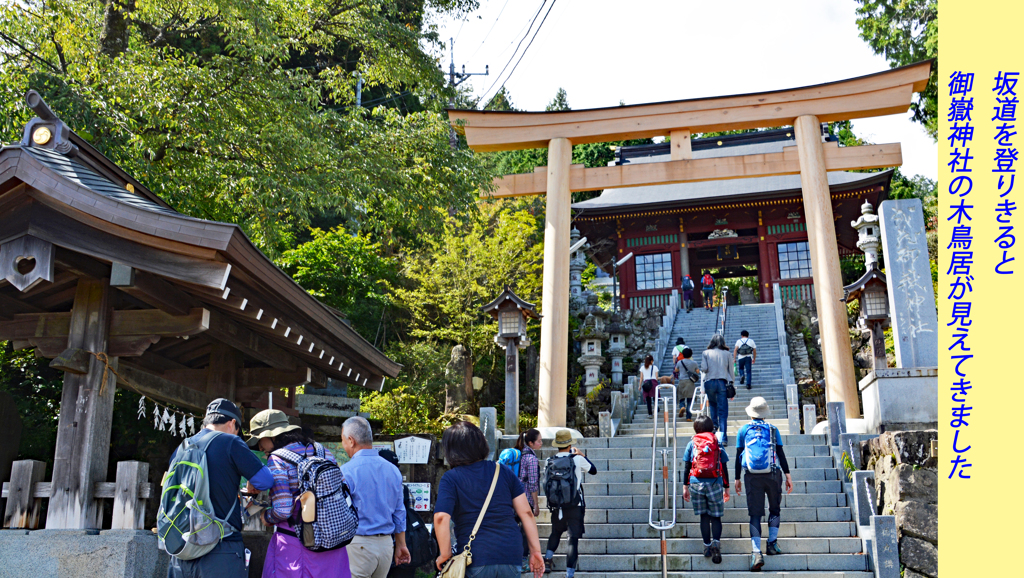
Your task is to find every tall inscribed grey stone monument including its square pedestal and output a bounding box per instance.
[859,199,939,434]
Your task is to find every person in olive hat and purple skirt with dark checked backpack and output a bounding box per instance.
[249,410,357,578]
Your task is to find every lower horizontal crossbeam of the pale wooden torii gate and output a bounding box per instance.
[480,142,903,198]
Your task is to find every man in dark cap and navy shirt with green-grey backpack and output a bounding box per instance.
[157,399,273,578]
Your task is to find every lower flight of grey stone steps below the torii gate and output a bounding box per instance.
[523,424,873,578]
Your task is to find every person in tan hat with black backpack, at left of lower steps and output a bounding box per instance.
[544,429,597,578]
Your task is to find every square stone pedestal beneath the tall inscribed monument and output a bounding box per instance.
[860,367,939,434]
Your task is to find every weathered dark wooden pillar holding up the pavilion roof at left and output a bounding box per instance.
[46,279,117,530]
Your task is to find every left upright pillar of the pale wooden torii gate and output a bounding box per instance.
[537,138,572,427]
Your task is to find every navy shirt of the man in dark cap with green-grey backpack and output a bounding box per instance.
[172,429,273,541]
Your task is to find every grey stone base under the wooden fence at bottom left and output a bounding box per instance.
[0,530,170,578]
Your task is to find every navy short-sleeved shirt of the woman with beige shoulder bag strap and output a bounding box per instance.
[434,460,525,568]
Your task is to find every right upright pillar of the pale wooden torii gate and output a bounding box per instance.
[794,115,860,417]
